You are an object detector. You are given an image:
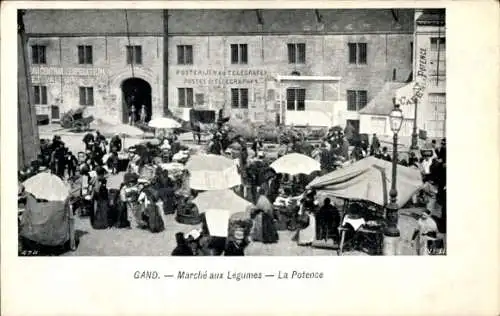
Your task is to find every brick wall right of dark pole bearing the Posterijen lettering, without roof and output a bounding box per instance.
[168,34,412,124]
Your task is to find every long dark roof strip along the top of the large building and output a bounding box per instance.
[24,9,414,35]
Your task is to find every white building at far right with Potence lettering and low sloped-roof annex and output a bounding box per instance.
[360,9,446,138]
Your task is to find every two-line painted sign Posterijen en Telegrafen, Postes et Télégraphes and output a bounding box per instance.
[175,69,267,85]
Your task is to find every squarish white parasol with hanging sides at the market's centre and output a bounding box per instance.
[186,154,241,191]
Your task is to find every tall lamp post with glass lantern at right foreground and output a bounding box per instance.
[383,99,403,256]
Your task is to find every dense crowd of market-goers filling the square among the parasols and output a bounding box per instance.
[19,116,446,255]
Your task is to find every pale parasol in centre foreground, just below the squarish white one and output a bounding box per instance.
[193,189,253,215]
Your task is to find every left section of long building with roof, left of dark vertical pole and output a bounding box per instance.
[25,10,164,123]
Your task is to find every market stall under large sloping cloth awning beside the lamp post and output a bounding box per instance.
[307,157,423,254]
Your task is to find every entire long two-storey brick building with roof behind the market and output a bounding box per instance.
[24,9,414,127]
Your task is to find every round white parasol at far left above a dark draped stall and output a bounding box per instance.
[23,172,70,201]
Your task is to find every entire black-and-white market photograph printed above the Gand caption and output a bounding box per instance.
[15,8,447,260]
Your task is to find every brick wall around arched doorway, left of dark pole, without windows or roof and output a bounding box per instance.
[29,36,163,123]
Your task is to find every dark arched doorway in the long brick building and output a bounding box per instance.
[121,78,152,123]
